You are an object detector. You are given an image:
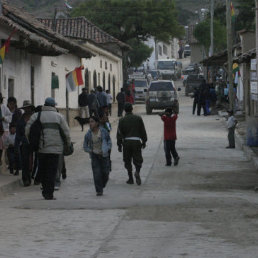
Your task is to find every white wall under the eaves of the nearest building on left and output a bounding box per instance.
[1,48,81,108]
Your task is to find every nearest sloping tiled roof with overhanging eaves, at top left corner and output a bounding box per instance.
[0,0,94,57]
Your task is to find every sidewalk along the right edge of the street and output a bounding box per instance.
[219,111,258,170]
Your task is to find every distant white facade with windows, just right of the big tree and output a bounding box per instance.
[144,37,179,69]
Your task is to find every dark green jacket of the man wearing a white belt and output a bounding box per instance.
[117,113,147,145]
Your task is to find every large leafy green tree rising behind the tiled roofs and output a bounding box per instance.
[72,0,184,66]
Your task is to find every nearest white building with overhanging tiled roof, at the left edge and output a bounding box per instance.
[0,1,94,124]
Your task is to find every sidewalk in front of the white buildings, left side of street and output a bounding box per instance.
[0,104,121,198]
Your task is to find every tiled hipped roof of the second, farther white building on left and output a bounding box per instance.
[38,17,130,49]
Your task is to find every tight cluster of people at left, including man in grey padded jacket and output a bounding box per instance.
[0,94,71,200]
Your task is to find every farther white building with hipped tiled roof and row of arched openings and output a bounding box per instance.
[39,17,130,100]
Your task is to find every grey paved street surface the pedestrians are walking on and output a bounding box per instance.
[0,83,258,258]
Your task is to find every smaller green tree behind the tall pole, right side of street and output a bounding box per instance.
[194,19,227,56]
